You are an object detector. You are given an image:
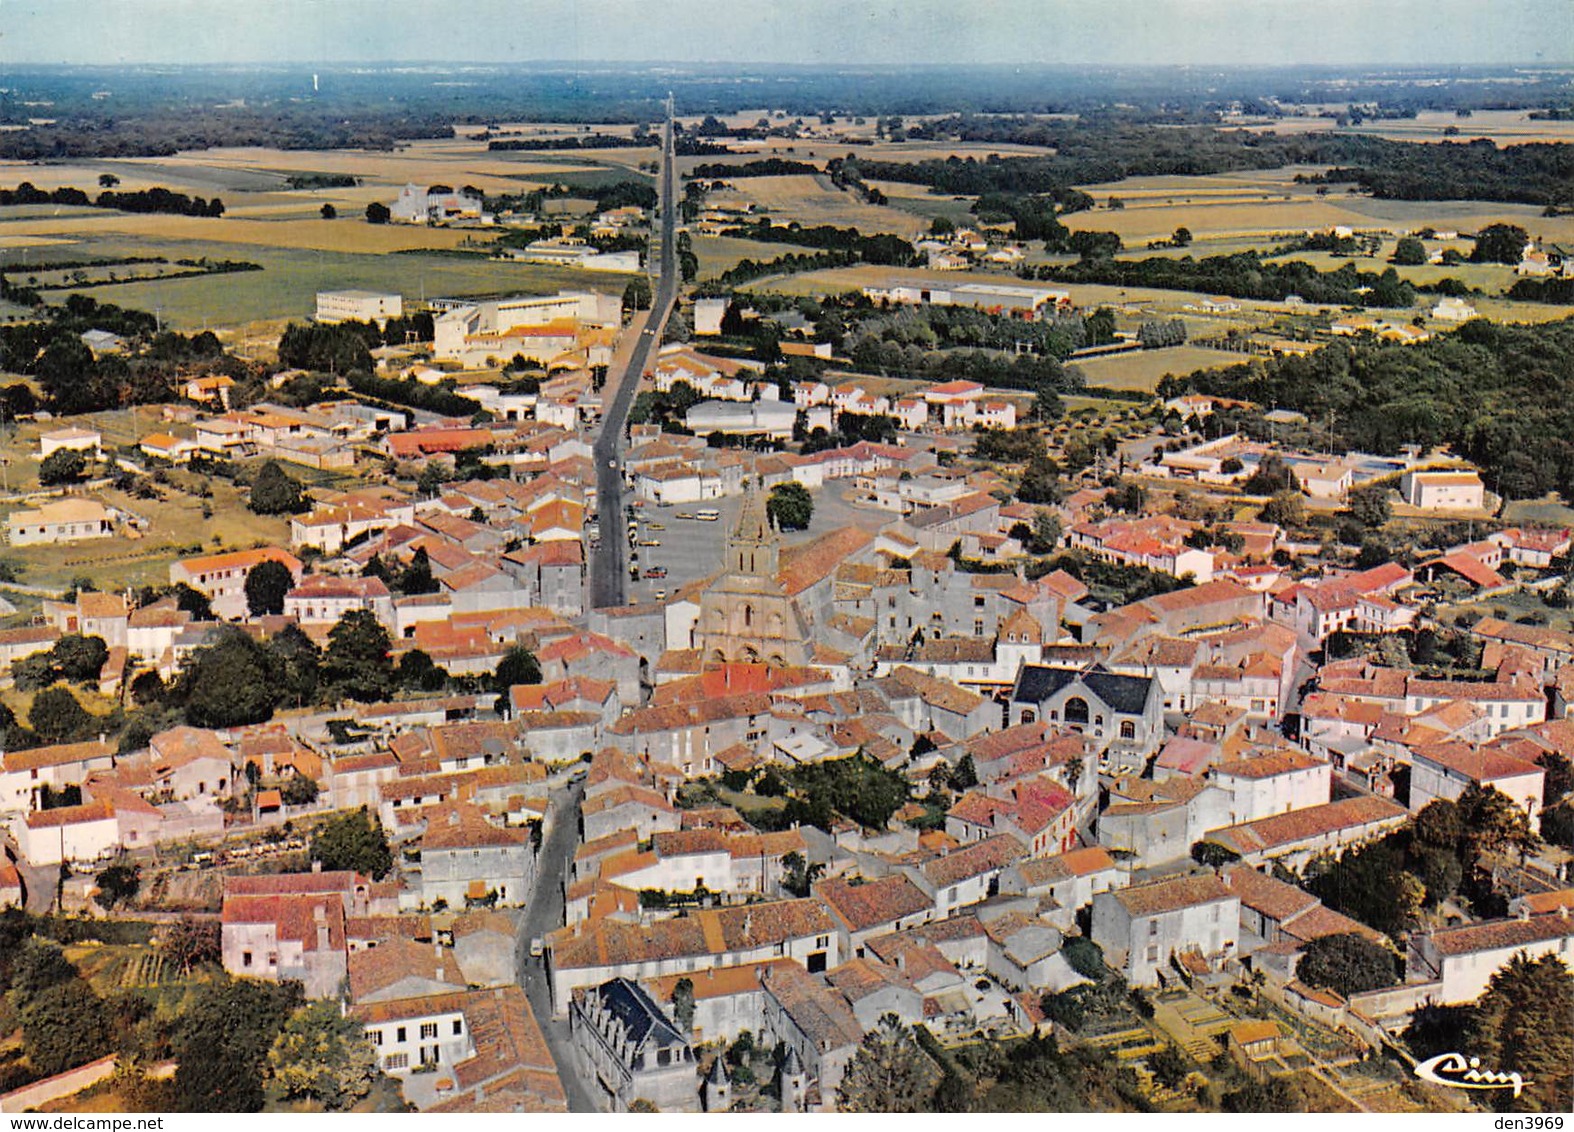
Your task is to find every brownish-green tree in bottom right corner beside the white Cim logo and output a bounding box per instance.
[1467,953,1574,1113]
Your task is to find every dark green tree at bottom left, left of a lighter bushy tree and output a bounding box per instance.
[175,978,302,1113]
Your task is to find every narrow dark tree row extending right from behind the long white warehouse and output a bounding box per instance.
[1034,252,1415,307]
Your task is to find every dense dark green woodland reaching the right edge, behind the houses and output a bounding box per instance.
[1157,318,1574,501]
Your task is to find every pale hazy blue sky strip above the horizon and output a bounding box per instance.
[0,0,1574,72]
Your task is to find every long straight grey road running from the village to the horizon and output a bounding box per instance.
[590,99,678,608]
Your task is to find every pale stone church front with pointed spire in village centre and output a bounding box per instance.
[694,485,814,666]
